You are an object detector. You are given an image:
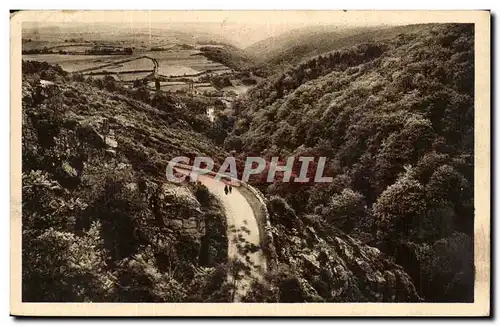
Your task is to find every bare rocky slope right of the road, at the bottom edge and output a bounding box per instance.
[273,225,421,302]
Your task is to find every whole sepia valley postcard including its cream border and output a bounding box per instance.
[11,10,490,316]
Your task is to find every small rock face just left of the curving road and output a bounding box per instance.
[154,183,205,240]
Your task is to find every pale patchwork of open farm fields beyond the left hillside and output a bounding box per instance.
[23,40,248,98]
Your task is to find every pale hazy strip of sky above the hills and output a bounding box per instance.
[18,10,476,47]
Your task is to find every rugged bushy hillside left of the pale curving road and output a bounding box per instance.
[22,61,234,302]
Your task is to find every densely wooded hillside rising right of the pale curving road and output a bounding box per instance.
[229,24,474,301]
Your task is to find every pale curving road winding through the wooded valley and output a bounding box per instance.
[174,167,266,302]
